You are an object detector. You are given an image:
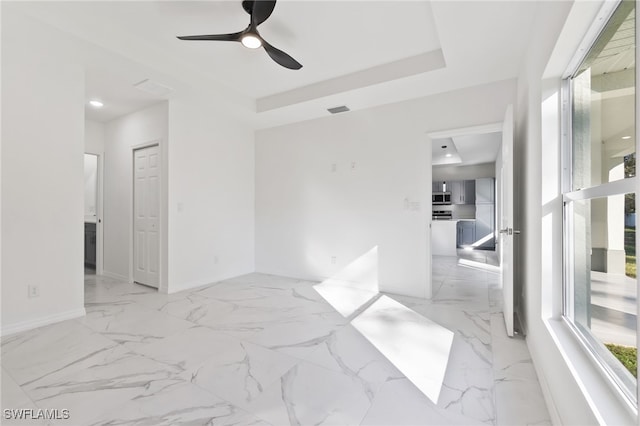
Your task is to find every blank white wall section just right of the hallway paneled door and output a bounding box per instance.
[168,94,255,292]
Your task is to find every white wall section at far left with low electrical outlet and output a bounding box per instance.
[2,10,84,334]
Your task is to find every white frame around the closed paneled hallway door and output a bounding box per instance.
[129,139,166,292]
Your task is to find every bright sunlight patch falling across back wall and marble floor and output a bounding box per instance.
[314,246,453,403]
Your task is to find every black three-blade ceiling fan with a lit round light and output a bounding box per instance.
[178,0,302,70]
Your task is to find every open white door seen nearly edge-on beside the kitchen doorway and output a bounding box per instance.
[499,105,514,336]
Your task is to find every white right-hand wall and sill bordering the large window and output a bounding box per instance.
[515,2,637,425]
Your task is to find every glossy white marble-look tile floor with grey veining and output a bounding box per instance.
[2,257,550,425]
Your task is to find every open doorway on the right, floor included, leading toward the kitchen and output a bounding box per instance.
[429,123,503,322]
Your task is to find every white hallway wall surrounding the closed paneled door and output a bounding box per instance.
[103,102,168,290]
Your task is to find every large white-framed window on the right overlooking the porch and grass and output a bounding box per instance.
[563,1,638,404]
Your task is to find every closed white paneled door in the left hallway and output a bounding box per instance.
[133,145,160,288]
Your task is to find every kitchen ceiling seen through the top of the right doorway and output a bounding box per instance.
[431,132,502,166]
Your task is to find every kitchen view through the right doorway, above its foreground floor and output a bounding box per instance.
[430,124,502,266]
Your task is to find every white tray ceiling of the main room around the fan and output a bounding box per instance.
[3,0,547,127]
